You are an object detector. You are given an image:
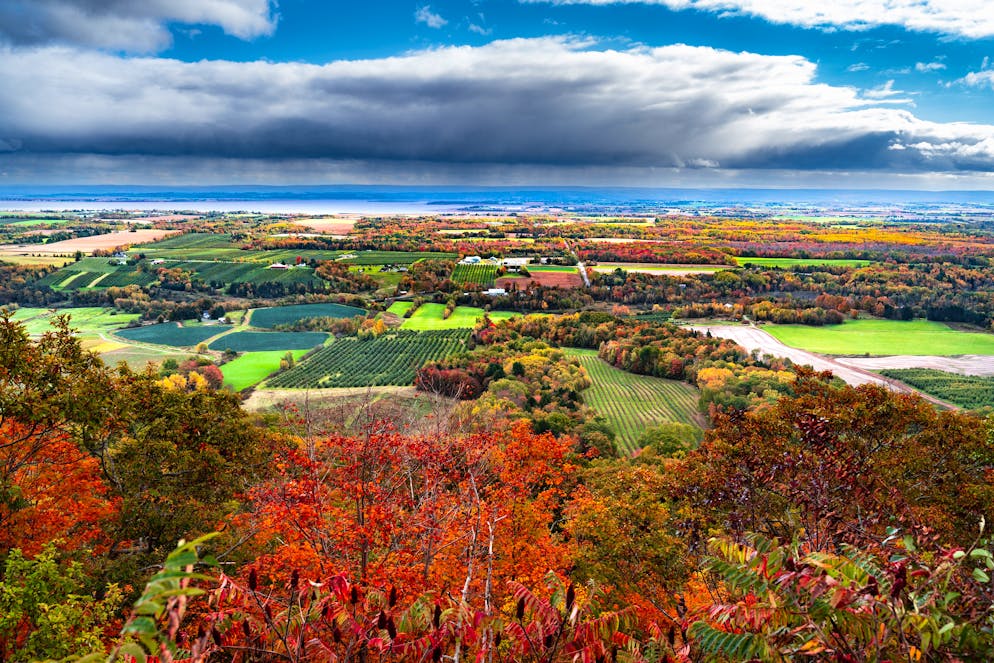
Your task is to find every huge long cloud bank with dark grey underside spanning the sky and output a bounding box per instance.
[0,38,994,171]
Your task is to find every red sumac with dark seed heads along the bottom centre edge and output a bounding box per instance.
[210,573,686,663]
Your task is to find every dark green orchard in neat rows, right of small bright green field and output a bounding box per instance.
[266,329,470,389]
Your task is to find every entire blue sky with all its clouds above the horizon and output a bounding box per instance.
[0,0,994,190]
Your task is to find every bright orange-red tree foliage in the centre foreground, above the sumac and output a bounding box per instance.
[237,422,573,596]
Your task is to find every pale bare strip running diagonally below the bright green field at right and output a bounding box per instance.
[689,325,959,410]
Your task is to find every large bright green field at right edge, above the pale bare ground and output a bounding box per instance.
[763,320,994,357]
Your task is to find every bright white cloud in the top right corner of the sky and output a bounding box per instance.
[520,0,994,39]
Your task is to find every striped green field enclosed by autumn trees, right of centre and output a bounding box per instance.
[568,349,700,453]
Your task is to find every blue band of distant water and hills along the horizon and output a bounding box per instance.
[0,186,994,214]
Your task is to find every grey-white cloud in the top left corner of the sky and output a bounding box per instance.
[0,0,276,53]
